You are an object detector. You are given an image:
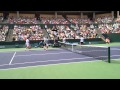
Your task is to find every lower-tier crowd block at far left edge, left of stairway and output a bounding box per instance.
[0,25,9,41]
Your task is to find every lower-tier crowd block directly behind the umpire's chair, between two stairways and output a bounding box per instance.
[46,25,79,40]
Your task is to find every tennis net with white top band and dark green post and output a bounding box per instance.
[59,42,110,63]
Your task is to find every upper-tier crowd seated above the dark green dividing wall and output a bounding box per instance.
[0,16,120,24]
